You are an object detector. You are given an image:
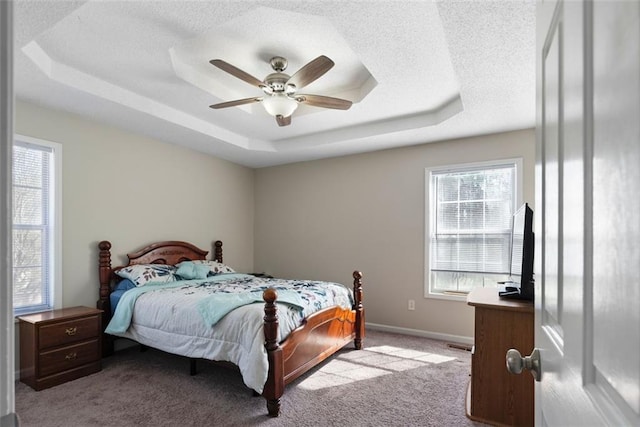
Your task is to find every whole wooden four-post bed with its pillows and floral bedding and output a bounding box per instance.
[97,241,365,417]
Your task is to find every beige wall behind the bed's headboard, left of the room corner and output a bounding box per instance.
[15,102,254,307]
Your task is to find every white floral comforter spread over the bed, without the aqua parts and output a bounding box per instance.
[107,274,353,393]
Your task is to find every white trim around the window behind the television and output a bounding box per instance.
[424,157,524,302]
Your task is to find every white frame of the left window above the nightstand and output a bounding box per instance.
[11,134,62,316]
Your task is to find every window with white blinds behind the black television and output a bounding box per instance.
[425,159,522,298]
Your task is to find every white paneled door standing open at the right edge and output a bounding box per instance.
[535,1,640,426]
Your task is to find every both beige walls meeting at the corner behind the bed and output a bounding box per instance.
[15,102,535,348]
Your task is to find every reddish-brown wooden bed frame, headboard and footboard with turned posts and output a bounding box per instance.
[97,240,365,417]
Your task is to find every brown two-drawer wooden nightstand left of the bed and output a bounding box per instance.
[18,307,102,390]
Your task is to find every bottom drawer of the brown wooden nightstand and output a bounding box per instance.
[39,338,101,377]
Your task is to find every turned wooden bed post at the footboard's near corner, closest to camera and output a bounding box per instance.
[262,288,284,417]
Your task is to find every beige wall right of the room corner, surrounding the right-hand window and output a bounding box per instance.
[255,130,535,338]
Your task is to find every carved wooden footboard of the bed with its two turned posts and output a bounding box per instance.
[262,271,364,417]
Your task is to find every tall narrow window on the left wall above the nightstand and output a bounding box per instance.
[13,136,62,315]
